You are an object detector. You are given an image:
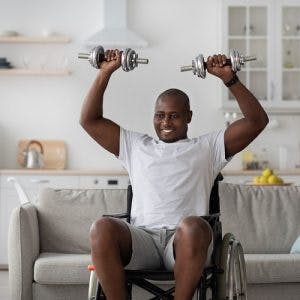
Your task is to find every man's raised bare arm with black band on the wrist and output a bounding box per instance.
[207,54,269,158]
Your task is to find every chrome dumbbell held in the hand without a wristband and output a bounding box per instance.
[78,46,149,72]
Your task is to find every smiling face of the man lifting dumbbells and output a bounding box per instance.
[153,95,192,143]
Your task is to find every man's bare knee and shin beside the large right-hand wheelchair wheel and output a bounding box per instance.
[174,217,212,300]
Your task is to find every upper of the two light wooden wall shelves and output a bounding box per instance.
[0,36,71,44]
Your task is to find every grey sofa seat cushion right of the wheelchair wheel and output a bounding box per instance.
[245,254,300,284]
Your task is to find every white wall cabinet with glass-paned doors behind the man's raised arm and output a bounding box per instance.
[222,0,300,114]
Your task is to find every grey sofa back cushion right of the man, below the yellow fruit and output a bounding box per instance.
[219,182,300,253]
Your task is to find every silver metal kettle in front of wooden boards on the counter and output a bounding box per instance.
[22,140,44,169]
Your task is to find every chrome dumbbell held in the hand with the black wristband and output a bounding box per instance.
[180,49,256,78]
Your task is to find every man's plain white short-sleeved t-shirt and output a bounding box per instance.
[118,128,227,229]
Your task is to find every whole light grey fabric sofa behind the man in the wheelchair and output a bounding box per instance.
[8,182,300,300]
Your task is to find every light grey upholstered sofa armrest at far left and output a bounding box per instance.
[8,203,40,300]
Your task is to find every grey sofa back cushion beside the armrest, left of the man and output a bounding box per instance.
[36,188,127,254]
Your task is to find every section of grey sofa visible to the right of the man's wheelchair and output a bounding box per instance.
[219,183,300,300]
